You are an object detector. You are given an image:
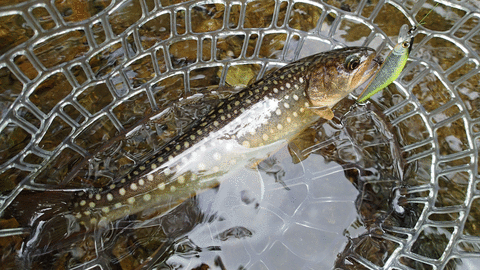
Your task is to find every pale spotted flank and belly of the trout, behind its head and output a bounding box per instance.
[73,84,319,228]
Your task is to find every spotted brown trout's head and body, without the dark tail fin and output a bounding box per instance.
[71,47,379,229]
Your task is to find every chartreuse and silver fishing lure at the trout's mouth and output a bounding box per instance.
[357,24,417,103]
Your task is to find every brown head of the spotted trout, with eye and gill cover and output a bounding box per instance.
[305,47,381,108]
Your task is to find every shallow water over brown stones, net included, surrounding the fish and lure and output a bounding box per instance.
[0,1,480,269]
